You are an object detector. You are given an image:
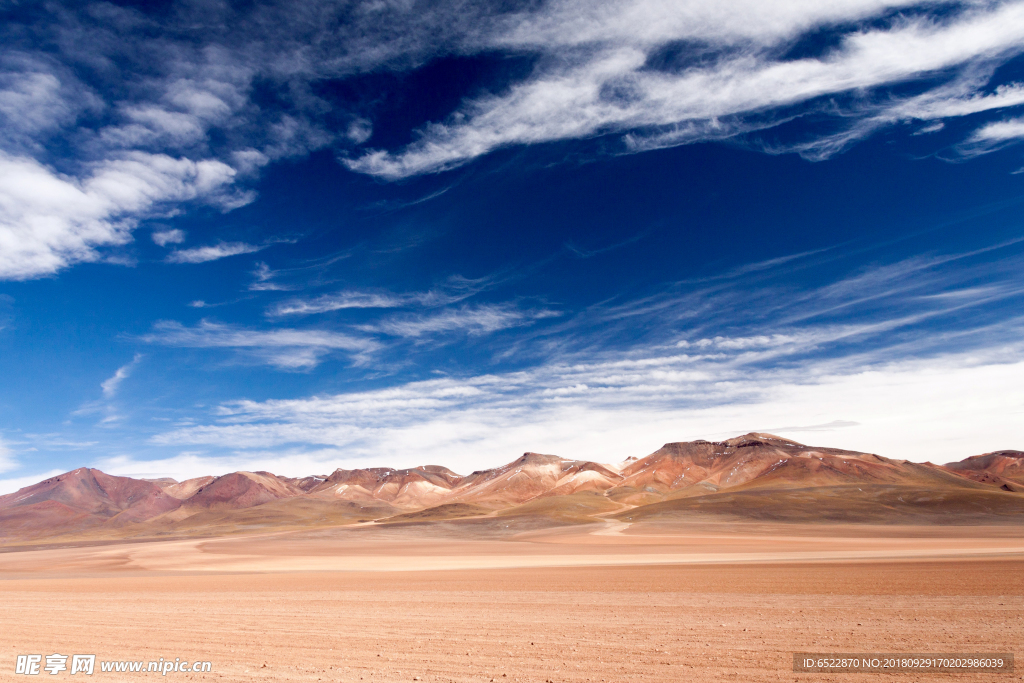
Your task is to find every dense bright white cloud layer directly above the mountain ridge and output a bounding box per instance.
[146,348,1024,474]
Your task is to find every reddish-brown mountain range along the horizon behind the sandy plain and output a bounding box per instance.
[0,433,1024,543]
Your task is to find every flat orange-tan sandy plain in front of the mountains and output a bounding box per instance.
[0,523,1024,683]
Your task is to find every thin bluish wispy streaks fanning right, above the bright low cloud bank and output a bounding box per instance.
[515,241,1024,357]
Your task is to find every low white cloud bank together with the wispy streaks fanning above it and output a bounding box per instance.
[123,242,1024,474]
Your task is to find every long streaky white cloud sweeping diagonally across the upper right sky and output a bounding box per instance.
[346,2,1024,178]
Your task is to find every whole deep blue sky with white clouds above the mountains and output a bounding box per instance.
[0,0,1024,493]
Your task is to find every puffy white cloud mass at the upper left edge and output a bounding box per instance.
[0,34,265,280]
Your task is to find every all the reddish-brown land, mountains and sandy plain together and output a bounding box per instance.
[0,437,1024,683]
